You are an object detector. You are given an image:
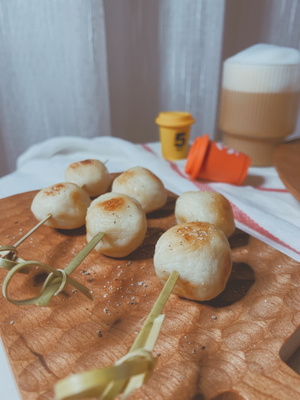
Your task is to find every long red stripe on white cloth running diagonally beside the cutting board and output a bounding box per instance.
[170,162,300,254]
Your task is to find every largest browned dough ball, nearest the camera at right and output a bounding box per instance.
[154,222,232,301]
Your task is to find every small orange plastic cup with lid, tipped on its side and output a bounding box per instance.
[185,134,251,185]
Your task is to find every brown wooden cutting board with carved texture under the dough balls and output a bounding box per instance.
[0,188,300,400]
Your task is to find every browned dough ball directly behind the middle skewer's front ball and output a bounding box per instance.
[112,167,167,214]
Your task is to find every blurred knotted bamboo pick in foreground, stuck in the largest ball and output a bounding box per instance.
[55,271,179,400]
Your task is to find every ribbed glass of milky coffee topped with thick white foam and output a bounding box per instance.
[219,45,300,166]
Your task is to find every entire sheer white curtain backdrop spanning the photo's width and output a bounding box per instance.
[0,0,300,176]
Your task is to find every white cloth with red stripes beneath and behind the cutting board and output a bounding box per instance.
[0,137,300,400]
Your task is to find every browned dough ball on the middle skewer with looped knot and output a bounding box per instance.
[86,192,147,258]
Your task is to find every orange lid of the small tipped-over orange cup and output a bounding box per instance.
[185,133,209,179]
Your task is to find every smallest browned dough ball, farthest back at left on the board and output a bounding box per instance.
[65,160,112,197]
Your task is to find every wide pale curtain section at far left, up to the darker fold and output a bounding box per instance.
[0,0,111,173]
